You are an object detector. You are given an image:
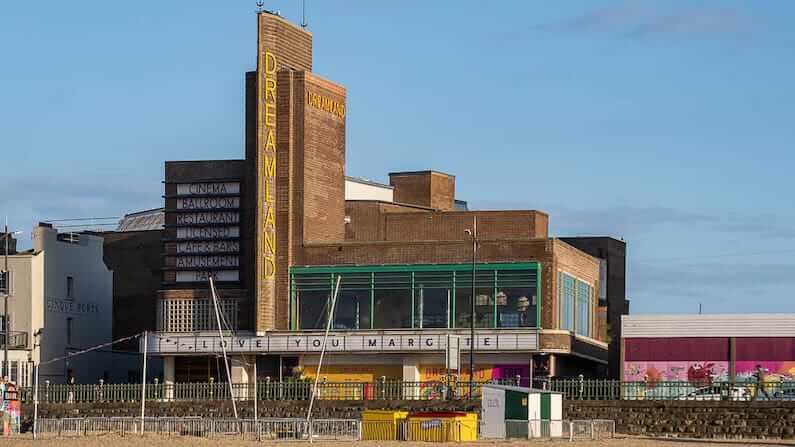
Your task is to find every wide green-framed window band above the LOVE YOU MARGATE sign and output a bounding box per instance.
[289,263,544,331]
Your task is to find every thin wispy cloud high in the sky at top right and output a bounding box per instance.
[533,0,758,40]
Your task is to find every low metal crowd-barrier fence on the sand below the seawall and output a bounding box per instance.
[31,417,615,443]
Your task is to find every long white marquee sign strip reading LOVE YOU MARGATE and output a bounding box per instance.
[148,331,538,354]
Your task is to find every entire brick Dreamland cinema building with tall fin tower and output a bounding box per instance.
[147,13,623,382]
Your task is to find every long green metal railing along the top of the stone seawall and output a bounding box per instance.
[18,379,795,403]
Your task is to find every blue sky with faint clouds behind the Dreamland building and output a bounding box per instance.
[0,0,795,313]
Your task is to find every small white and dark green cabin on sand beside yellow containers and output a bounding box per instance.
[481,385,563,439]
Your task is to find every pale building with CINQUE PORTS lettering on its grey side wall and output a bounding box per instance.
[0,224,113,386]
